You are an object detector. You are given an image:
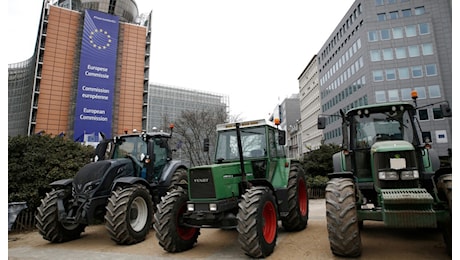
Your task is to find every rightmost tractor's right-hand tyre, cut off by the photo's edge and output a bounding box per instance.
[436,174,452,255]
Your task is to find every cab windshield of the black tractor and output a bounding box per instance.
[113,136,147,161]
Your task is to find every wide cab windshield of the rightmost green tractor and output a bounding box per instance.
[353,107,414,148]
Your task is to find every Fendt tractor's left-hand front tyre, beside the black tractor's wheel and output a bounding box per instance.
[153,189,200,253]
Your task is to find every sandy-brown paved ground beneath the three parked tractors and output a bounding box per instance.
[8,199,455,260]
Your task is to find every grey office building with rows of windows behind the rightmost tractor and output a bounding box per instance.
[317,0,452,156]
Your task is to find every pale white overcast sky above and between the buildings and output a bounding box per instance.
[6,0,354,120]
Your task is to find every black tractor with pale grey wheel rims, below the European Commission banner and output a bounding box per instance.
[35,125,187,245]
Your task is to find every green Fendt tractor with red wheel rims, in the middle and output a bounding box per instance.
[154,120,309,257]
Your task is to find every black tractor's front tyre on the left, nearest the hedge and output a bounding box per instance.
[35,189,86,243]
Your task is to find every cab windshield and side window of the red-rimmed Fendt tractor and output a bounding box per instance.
[216,127,267,160]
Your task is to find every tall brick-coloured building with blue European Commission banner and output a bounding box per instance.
[8,0,151,141]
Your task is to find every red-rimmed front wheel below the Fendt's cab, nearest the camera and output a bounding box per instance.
[236,187,278,258]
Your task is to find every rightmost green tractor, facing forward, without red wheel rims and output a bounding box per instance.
[318,99,452,257]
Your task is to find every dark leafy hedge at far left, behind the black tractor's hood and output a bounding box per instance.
[8,135,94,208]
